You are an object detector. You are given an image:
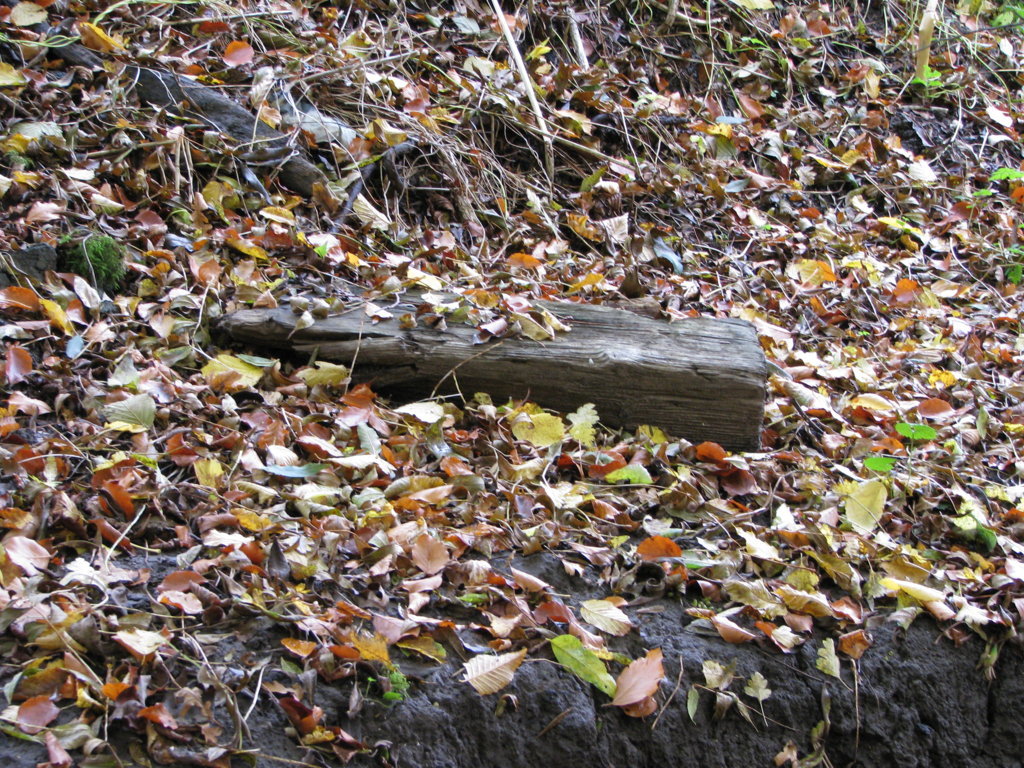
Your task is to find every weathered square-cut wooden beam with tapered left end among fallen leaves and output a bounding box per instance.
[218,303,766,451]
